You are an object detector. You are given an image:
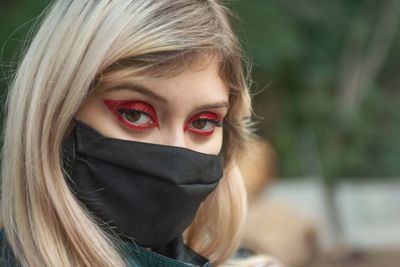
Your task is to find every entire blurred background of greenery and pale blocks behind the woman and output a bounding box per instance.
[0,0,400,267]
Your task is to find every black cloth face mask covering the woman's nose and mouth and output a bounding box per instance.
[63,121,223,246]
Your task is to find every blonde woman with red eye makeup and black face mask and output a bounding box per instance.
[1,0,251,267]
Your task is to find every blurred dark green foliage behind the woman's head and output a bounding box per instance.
[0,0,400,181]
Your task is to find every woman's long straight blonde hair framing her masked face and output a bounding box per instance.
[1,0,251,267]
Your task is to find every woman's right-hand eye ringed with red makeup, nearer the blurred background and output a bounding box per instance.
[185,112,223,136]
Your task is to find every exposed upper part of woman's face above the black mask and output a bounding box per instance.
[75,59,229,154]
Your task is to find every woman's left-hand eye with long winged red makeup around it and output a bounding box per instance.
[103,99,159,130]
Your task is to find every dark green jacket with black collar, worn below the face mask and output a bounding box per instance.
[0,230,211,267]
